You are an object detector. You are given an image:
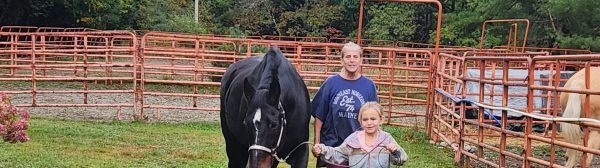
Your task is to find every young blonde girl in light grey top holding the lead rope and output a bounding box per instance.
[312,102,408,168]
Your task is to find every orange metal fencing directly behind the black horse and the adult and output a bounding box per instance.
[141,32,431,127]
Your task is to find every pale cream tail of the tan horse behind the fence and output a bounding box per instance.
[562,80,585,144]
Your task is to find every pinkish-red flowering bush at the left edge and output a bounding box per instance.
[0,93,29,143]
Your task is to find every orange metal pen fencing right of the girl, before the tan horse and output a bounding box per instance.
[431,49,600,167]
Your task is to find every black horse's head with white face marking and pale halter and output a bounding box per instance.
[244,46,286,167]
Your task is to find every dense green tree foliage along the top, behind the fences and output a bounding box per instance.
[0,0,600,51]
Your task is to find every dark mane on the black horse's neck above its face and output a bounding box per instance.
[256,46,283,90]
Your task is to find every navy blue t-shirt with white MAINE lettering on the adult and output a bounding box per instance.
[311,75,377,146]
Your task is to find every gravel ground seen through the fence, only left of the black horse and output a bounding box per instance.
[10,94,219,122]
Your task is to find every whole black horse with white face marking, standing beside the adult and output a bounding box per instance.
[221,47,310,168]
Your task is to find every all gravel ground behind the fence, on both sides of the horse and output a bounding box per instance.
[0,77,425,125]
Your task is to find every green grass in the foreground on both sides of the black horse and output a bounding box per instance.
[0,118,455,167]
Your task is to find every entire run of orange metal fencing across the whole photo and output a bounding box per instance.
[5,28,600,167]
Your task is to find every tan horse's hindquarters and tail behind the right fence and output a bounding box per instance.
[560,67,600,167]
